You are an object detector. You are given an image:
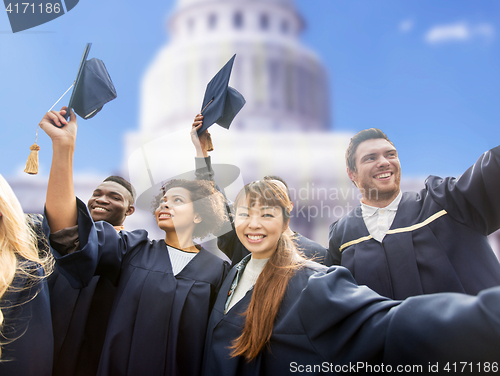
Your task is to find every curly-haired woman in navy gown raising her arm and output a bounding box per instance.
[40,109,228,376]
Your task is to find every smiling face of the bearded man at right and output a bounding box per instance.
[347,138,401,206]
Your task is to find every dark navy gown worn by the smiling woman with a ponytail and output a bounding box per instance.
[203,263,500,376]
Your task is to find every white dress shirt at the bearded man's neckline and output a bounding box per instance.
[361,191,403,242]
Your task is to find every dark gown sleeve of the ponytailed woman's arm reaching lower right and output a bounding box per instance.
[298,267,500,371]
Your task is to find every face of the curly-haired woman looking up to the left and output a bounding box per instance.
[155,187,201,234]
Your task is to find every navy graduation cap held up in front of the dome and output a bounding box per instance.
[198,55,246,134]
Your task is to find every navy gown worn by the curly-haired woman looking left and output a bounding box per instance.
[44,200,228,376]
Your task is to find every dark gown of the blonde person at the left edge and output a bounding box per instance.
[0,261,54,376]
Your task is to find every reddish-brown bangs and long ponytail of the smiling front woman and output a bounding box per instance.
[229,180,306,361]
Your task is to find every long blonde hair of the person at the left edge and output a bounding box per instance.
[0,175,53,358]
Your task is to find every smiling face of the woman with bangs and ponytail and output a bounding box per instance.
[235,200,286,259]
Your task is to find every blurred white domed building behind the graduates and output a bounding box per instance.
[124,0,357,241]
